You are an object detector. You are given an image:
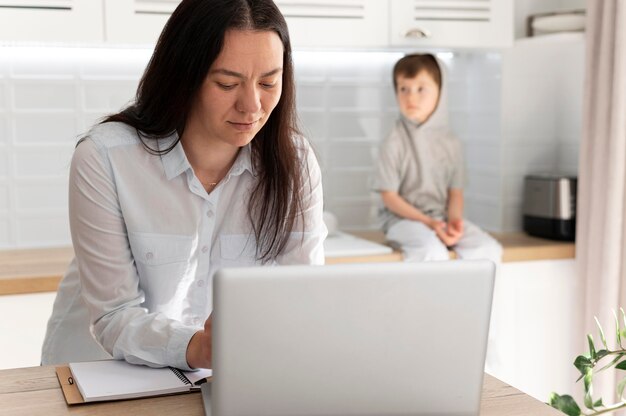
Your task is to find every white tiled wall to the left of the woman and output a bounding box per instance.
[0,46,150,248]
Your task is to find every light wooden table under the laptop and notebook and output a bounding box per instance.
[0,366,563,416]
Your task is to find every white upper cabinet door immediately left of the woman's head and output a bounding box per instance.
[104,0,180,44]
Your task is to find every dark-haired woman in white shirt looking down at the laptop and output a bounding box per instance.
[42,0,326,369]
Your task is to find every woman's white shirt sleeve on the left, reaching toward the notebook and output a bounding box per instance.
[69,139,197,370]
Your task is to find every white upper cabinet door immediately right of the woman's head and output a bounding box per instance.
[275,0,389,49]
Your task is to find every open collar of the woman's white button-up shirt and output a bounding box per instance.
[161,133,256,180]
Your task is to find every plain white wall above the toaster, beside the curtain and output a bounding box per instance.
[500,33,585,231]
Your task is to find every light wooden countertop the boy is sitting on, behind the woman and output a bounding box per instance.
[0,231,575,295]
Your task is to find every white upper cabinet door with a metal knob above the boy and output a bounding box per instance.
[390,0,514,48]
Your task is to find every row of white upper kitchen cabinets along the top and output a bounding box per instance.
[0,0,513,49]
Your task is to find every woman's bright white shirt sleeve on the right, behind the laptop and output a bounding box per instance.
[275,139,328,265]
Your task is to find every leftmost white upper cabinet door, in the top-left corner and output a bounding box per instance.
[0,0,103,42]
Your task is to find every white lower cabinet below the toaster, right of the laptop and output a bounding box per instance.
[487,259,585,401]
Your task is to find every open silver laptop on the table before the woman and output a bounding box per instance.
[203,260,495,416]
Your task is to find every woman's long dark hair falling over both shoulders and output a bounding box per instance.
[103,0,306,262]
